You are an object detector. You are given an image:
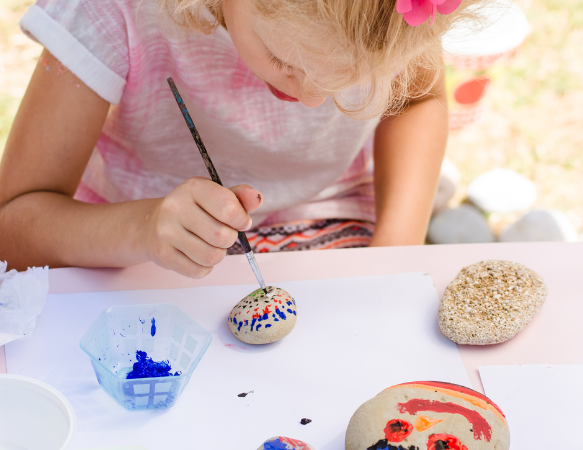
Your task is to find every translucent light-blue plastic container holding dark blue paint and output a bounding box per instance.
[80,304,212,410]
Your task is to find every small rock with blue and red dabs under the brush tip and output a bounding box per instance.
[229,286,297,344]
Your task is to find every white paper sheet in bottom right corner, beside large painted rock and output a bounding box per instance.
[480,364,583,450]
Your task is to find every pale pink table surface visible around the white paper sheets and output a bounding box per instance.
[0,242,583,392]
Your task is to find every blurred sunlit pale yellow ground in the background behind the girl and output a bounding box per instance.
[0,0,583,233]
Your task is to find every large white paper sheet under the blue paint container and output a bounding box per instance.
[6,273,470,450]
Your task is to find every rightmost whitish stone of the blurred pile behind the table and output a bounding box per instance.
[500,209,578,242]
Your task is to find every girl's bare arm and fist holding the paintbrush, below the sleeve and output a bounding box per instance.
[0,50,261,277]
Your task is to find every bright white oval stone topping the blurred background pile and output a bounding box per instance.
[467,169,536,213]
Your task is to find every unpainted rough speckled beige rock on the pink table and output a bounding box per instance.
[438,261,547,345]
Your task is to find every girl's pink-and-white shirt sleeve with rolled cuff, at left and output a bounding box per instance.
[20,0,131,104]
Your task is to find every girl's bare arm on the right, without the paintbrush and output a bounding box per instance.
[370,63,448,246]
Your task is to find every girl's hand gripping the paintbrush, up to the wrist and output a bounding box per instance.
[144,177,263,278]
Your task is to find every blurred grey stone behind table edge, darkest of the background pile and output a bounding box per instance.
[427,204,495,244]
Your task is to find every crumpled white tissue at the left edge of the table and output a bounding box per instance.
[0,261,49,345]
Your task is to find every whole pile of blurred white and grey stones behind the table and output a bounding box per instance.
[427,163,579,244]
